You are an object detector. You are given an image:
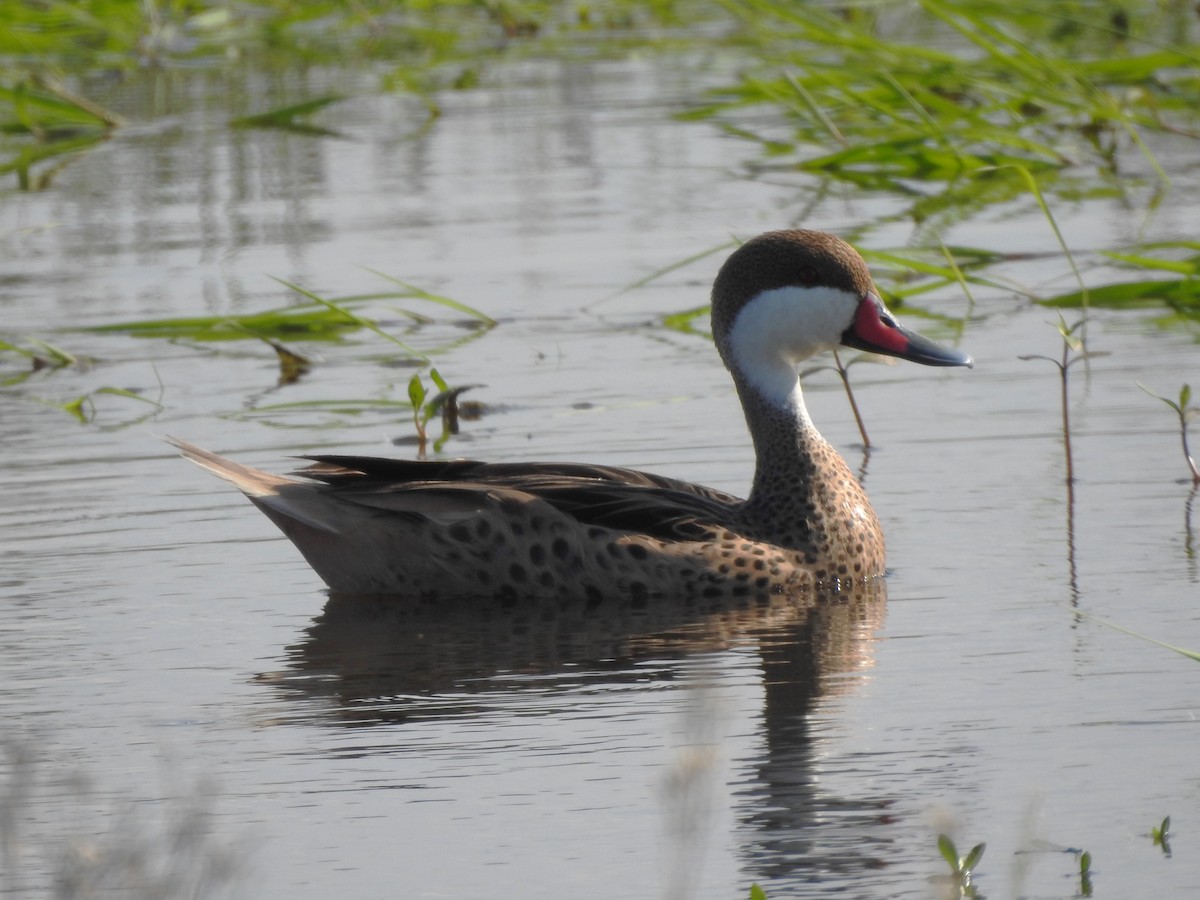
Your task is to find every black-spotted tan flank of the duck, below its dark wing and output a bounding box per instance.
[247,468,840,602]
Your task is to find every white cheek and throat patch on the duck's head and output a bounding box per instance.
[730,287,859,406]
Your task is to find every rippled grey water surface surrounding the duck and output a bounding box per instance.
[0,47,1200,898]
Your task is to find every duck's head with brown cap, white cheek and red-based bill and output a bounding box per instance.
[712,229,972,396]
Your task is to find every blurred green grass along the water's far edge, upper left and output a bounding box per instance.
[0,0,710,190]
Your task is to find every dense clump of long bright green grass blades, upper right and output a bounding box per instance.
[692,0,1200,218]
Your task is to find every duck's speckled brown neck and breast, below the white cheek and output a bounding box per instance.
[733,365,883,574]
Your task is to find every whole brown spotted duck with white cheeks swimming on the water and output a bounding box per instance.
[168,229,973,604]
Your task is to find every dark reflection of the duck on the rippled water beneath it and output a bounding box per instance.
[270,580,887,888]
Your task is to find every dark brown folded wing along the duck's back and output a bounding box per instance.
[294,456,742,541]
